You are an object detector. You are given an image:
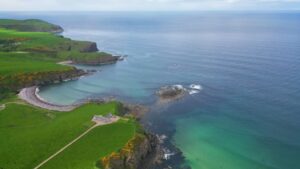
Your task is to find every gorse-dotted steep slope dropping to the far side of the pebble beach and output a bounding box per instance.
[0,68,86,91]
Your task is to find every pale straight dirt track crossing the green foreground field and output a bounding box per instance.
[34,117,120,169]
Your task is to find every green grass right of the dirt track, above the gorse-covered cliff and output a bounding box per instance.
[41,121,135,169]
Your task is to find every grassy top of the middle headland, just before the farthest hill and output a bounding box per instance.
[0,29,112,61]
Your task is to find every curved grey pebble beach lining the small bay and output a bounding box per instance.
[18,86,78,111]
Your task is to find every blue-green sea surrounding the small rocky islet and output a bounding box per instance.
[1,12,300,169]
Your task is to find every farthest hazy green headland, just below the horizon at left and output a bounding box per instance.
[0,19,63,33]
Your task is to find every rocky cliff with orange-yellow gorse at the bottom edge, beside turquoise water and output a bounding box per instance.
[100,134,163,169]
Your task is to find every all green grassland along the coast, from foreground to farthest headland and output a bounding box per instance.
[0,19,139,169]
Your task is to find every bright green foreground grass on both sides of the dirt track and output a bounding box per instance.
[0,102,135,169]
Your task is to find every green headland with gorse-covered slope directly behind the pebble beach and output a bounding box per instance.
[0,52,84,92]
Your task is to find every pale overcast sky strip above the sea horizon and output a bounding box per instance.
[0,0,300,11]
